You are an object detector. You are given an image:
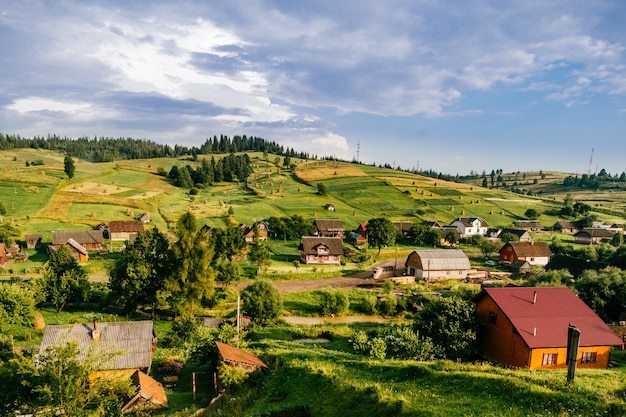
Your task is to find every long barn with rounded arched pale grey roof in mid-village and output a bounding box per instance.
[405,249,472,281]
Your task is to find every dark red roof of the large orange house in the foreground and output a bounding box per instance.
[477,287,622,349]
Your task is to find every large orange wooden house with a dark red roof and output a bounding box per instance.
[474,287,622,369]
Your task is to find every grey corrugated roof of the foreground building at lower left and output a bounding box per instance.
[39,320,156,370]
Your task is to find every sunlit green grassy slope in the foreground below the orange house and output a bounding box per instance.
[208,326,626,417]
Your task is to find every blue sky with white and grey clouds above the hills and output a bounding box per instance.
[0,0,626,174]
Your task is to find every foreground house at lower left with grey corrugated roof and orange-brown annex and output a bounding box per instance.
[39,320,167,411]
